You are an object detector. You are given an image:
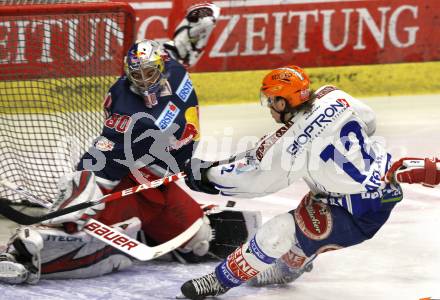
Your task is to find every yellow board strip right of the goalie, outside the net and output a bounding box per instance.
[191,62,440,104]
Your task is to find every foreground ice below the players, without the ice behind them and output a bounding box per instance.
[0,188,440,300]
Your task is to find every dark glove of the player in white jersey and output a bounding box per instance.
[184,158,220,195]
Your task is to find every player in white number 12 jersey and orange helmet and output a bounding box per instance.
[181,66,402,299]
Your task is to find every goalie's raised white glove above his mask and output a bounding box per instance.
[163,3,220,67]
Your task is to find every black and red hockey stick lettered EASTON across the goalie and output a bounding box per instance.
[0,172,185,225]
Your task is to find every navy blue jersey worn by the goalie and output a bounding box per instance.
[78,59,200,181]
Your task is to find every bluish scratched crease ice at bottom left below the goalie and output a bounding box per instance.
[0,262,296,300]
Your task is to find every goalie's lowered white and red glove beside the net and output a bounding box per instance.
[44,170,105,233]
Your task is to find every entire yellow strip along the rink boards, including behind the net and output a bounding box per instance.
[0,62,440,110]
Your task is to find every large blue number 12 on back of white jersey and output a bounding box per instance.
[320,121,376,183]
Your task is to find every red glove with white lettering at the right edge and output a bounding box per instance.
[385,157,440,187]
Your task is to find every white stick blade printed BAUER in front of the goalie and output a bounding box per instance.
[84,218,203,261]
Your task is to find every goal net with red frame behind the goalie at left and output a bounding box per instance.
[0,0,135,202]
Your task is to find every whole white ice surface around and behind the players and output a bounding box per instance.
[0,95,440,300]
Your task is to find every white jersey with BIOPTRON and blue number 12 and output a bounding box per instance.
[207,86,398,213]
